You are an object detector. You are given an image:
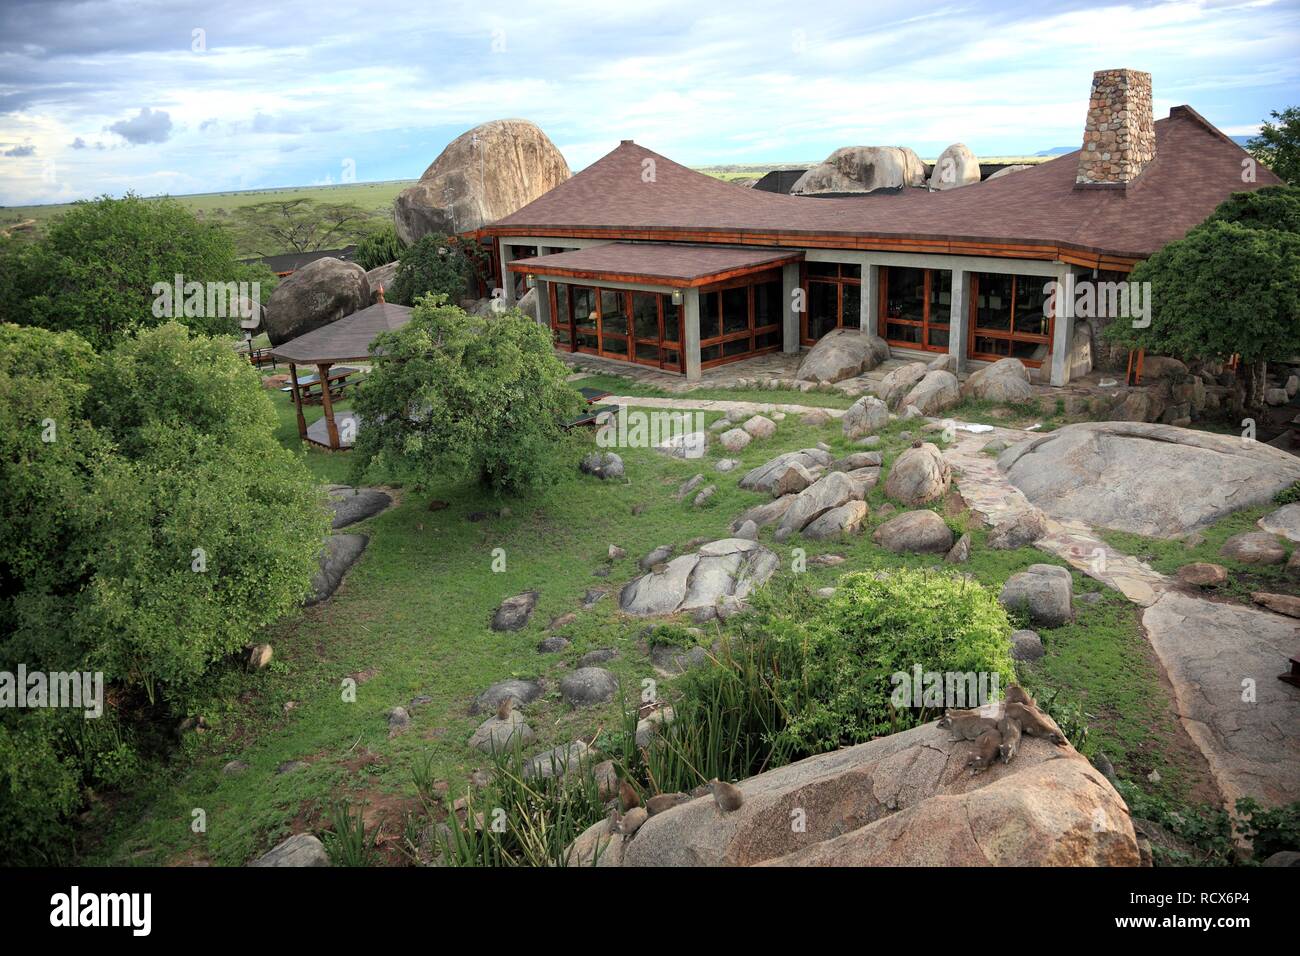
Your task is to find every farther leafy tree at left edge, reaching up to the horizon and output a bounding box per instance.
[0,194,274,349]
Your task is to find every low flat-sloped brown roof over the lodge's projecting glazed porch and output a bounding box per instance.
[510,242,803,286]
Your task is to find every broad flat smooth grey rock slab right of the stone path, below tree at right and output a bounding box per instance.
[997,421,1300,537]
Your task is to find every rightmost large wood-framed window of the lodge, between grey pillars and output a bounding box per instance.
[969,272,1052,368]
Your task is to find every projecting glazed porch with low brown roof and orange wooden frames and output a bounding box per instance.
[508,242,803,381]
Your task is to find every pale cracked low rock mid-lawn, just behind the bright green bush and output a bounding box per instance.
[619,537,780,615]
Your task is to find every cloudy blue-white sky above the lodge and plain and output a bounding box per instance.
[0,0,1300,204]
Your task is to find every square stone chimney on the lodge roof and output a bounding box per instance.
[1074,70,1156,187]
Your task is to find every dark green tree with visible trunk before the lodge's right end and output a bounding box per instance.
[1104,197,1300,406]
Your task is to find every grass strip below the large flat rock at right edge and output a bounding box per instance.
[1097,505,1296,604]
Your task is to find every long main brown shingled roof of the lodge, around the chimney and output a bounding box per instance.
[488,107,1281,259]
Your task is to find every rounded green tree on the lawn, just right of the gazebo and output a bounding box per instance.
[354,295,582,490]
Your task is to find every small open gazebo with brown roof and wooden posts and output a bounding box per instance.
[272,300,411,451]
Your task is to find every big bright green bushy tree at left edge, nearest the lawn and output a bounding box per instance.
[0,323,328,701]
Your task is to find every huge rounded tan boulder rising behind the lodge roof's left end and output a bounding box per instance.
[393,120,569,243]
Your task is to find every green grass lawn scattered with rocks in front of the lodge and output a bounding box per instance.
[86,376,1216,865]
